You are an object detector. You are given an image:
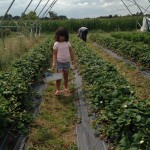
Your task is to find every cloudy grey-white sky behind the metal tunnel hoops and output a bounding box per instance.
[0,0,150,18]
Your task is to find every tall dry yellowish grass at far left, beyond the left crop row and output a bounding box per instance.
[0,33,43,70]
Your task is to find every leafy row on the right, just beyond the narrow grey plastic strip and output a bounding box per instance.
[90,34,150,70]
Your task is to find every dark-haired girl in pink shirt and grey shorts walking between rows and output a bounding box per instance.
[53,27,75,96]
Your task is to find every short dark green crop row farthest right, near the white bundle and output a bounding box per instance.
[111,32,150,44]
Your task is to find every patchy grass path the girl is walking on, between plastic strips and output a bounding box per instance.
[29,70,77,150]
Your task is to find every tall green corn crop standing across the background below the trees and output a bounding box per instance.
[2,16,142,32]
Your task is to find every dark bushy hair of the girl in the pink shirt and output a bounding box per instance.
[55,27,69,42]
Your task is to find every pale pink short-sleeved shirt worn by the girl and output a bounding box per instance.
[53,41,71,63]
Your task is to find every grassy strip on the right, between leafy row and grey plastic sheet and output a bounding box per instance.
[88,40,150,100]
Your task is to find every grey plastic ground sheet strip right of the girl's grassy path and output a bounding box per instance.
[74,70,107,150]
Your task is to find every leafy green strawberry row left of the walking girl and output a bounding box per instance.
[0,39,52,138]
